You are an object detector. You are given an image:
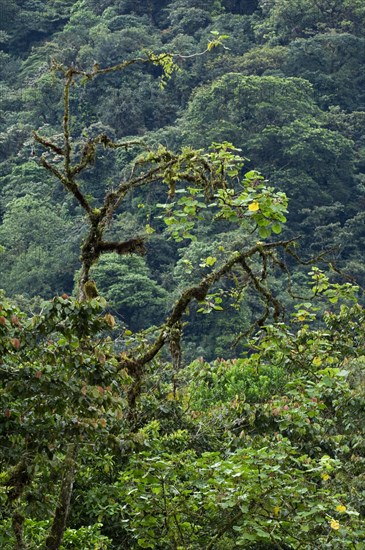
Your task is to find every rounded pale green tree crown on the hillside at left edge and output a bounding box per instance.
[0,195,80,298]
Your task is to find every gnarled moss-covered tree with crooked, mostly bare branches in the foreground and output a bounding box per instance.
[2,48,290,548]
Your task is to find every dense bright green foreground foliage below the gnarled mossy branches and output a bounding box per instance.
[0,270,365,550]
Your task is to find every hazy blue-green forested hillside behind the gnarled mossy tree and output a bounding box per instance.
[0,0,365,350]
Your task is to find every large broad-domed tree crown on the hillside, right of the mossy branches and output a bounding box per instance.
[181,73,358,253]
